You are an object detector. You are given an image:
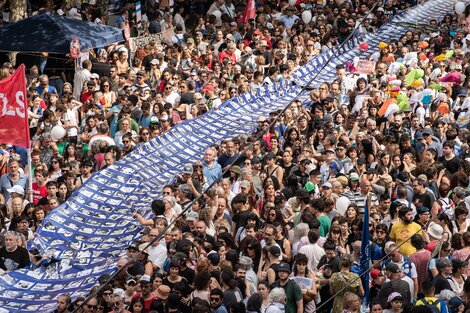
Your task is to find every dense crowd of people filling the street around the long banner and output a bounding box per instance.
[0,0,470,313]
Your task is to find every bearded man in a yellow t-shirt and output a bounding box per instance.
[390,207,424,257]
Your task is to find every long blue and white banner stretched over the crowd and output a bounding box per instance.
[0,0,456,312]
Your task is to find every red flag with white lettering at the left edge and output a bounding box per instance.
[0,64,30,149]
